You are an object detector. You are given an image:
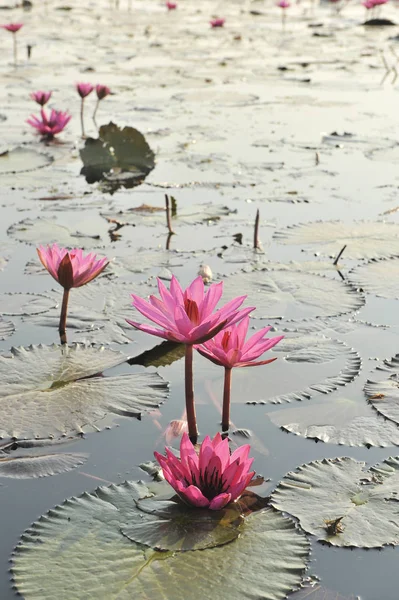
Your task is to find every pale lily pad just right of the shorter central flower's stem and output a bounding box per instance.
[238,332,361,404]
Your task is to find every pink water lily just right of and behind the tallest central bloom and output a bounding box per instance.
[196,317,284,369]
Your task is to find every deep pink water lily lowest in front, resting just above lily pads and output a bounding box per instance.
[154,433,255,510]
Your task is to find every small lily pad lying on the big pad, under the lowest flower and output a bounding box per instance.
[121,499,243,552]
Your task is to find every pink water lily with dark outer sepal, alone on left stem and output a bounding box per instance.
[36,244,108,290]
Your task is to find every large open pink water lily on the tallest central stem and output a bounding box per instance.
[126,276,254,345]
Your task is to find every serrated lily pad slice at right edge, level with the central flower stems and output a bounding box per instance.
[364,354,399,424]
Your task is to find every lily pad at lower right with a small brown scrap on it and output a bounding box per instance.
[271,457,399,548]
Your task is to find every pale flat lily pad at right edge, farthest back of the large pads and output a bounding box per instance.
[274,221,399,259]
